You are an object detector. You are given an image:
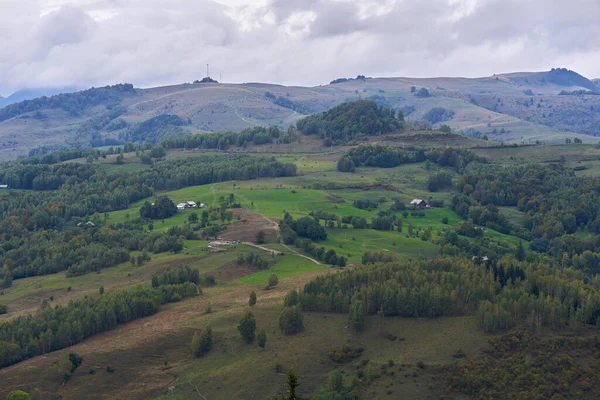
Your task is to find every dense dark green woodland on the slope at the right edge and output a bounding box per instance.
[451,164,600,273]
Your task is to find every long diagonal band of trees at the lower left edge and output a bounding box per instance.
[0,282,198,367]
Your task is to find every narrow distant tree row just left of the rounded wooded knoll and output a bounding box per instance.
[161,126,296,150]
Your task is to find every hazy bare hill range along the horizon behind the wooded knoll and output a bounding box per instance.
[0,69,600,160]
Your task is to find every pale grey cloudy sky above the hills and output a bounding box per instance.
[0,0,600,95]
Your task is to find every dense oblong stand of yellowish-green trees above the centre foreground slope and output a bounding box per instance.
[300,258,500,317]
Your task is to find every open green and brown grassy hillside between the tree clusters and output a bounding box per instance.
[5,138,600,400]
